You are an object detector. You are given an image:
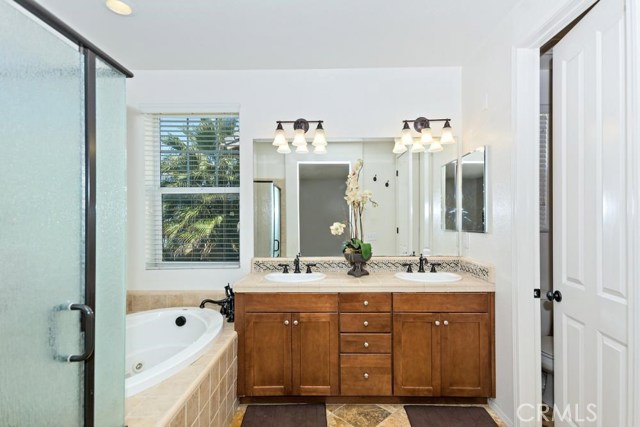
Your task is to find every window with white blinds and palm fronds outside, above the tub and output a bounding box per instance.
[145,114,240,268]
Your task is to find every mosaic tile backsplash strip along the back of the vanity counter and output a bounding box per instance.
[251,256,495,283]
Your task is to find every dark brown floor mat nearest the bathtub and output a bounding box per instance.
[241,405,327,427]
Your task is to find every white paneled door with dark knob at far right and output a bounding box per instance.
[553,0,629,427]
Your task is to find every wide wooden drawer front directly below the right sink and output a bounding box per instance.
[393,292,489,313]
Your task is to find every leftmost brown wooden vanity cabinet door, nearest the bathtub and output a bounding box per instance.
[244,313,292,396]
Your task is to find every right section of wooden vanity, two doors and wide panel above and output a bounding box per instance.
[393,293,495,397]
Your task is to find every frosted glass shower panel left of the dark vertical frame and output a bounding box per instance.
[0,2,85,427]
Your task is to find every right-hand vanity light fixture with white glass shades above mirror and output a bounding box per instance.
[393,117,455,154]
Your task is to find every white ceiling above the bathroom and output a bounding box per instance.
[39,0,517,70]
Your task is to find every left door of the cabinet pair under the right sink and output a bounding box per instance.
[393,313,442,396]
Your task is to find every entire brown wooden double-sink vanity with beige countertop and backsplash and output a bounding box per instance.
[235,257,495,401]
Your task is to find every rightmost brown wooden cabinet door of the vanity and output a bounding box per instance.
[440,313,491,397]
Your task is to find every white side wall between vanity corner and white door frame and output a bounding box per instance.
[462,0,592,425]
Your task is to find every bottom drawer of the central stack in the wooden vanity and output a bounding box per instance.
[340,354,391,396]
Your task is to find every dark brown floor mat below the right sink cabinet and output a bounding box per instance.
[404,405,497,427]
